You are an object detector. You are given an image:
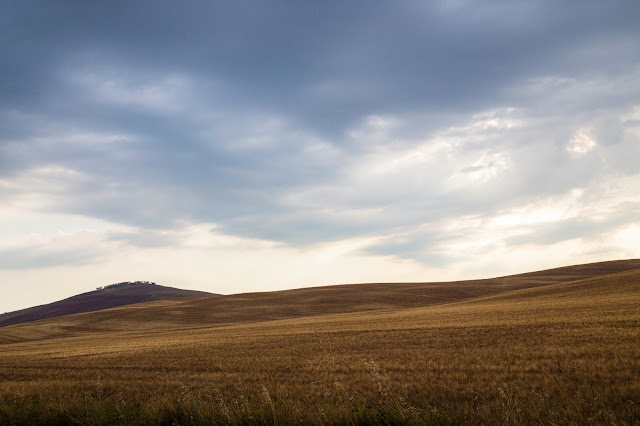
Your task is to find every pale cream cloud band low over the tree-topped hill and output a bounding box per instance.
[0,216,446,311]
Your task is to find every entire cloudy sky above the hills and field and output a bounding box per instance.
[0,0,640,312]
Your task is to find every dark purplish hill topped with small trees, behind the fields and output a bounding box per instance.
[0,281,217,327]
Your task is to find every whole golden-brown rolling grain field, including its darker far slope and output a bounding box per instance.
[0,260,640,424]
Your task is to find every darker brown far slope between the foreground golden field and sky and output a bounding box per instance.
[0,259,640,345]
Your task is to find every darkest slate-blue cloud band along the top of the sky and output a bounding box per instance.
[2,1,639,125]
